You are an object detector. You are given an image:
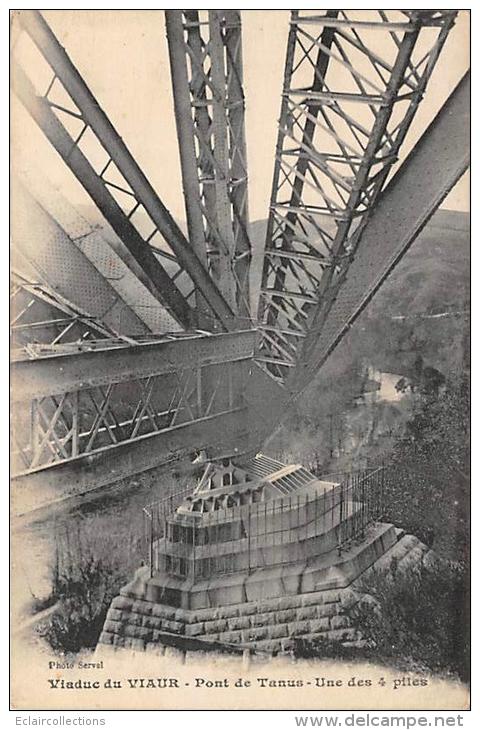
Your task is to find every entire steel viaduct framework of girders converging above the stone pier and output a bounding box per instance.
[11,10,470,514]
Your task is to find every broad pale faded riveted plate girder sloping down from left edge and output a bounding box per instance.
[12,169,182,335]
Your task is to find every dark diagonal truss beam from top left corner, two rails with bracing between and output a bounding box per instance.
[13,10,233,330]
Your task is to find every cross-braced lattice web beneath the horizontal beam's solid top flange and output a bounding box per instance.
[12,355,249,475]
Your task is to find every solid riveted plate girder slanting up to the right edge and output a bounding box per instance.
[289,73,470,392]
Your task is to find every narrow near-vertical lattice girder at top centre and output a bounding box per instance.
[165,10,251,318]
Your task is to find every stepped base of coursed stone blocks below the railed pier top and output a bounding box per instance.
[100,524,429,654]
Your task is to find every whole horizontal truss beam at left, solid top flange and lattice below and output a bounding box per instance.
[12,331,255,478]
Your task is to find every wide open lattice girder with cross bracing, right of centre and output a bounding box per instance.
[258,10,456,388]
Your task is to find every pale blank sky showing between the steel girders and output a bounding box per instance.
[12,10,469,220]
